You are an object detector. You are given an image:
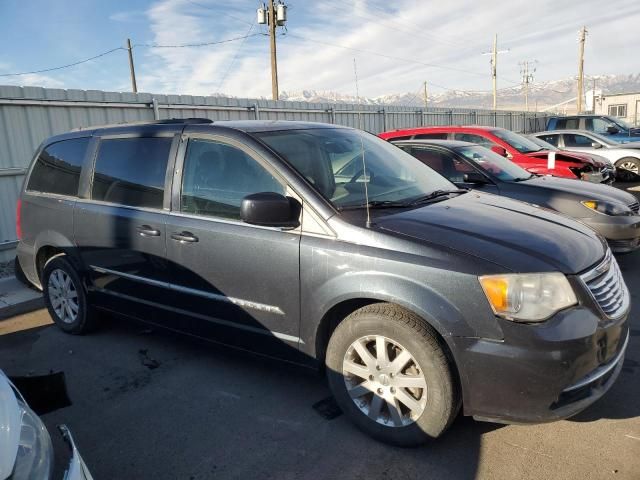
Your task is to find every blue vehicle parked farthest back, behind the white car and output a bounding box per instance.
[547,115,640,142]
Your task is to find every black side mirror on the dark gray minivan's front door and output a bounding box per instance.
[240,192,302,228]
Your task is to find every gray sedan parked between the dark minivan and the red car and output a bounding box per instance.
[393,140,640,253]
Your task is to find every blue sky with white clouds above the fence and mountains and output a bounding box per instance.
[0,0,640,98]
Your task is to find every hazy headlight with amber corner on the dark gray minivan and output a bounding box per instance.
[479,272,578,322]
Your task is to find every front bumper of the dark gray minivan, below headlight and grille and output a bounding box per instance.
[455,306,629,423]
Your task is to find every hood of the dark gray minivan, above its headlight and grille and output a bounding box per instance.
[375,191,606,274]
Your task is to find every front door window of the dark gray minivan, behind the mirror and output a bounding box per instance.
[181,139,285,220]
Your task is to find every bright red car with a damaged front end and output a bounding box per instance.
[379,126,614,183]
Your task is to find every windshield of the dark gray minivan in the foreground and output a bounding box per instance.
[255,128,456,209]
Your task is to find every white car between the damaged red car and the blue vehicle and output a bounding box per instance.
[534,130,640,175]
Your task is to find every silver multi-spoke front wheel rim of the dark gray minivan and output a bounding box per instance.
[342,335,427,427]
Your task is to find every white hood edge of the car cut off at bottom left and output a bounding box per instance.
[0,370,22,480]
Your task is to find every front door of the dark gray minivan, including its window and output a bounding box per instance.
[167,136,300,356]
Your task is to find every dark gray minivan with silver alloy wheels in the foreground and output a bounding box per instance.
[18,119,630,445]
